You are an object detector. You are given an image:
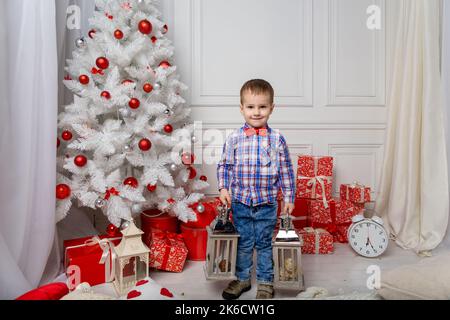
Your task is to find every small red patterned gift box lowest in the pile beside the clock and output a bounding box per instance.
[299,227,334,254]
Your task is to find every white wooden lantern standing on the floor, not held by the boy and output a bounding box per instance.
[114,221,150,295]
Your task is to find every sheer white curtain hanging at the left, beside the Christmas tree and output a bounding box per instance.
[0,0,58,299]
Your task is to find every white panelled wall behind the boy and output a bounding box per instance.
[167,0,397,197]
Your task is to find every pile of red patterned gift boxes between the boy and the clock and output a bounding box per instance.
[279,155,370,254]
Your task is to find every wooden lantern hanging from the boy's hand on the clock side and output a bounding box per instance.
[272,216,305,291]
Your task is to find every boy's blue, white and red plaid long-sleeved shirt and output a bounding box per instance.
[217,123,295,206]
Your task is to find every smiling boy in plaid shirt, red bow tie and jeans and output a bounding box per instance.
[217,79,295,299]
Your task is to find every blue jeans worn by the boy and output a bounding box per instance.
[231,200,277,284]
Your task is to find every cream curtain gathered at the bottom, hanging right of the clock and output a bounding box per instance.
[376,0,449,254]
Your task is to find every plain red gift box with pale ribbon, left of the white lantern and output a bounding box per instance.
[64,235,122,286]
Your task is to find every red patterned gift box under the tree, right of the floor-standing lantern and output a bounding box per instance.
[149,232,188,272]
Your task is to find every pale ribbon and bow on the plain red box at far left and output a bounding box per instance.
[65,236,122,282]
